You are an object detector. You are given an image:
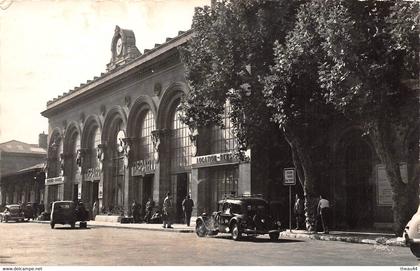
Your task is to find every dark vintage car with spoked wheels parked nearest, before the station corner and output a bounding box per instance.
[196,196,281,240]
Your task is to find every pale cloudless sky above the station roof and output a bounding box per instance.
[0,0,210,144]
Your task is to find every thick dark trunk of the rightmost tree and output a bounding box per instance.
[371,120,419,236]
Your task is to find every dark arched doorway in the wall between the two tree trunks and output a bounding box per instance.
[344,138,375,229]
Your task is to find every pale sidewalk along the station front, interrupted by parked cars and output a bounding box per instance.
[33,220,406,249]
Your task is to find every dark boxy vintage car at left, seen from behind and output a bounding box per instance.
[50,201,89,229]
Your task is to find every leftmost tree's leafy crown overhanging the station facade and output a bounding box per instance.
[181,0,298,193]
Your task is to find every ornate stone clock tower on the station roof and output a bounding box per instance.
[107,25,141,71]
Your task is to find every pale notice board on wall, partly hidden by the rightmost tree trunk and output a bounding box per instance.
[376,163,408,206]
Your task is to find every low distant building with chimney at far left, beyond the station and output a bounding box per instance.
[0,133,47,205]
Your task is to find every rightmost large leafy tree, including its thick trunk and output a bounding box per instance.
[317,0,419,234]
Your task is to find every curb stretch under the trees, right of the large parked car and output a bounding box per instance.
[280,231,407,247]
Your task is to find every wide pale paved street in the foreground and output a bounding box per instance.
[0,223,418,266]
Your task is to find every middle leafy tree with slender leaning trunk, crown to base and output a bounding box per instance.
[263,2,337,231]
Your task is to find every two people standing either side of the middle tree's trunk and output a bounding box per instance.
[293,194,330,233]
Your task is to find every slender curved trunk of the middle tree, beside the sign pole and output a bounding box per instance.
[284,127,318,232]
